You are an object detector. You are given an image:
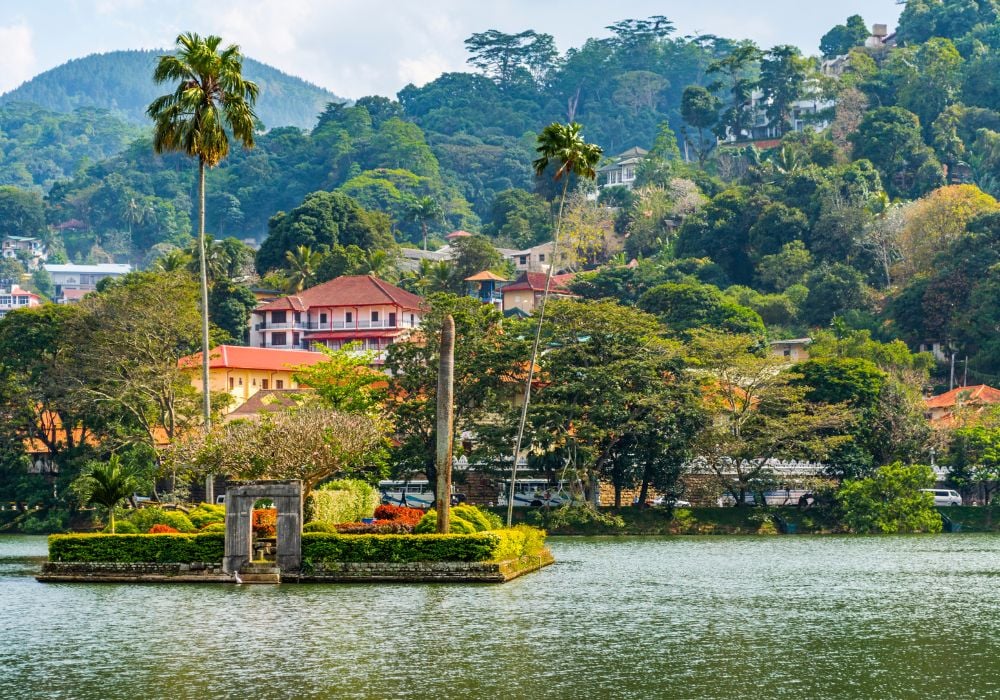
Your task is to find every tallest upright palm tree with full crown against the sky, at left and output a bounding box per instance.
[146,32,258,442]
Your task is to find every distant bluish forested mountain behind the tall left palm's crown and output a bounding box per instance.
[0,51,345,129]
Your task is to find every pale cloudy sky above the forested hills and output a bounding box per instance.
[0,0,901,99]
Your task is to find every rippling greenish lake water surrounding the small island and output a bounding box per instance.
[0,535,1000,699]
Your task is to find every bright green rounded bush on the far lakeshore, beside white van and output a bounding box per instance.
[836,462,942,534]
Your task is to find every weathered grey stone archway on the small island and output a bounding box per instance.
[222,480,302,574]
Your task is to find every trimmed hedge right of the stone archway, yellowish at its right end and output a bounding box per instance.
[302,526,545,566]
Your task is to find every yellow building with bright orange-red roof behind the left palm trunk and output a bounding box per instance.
[177,345,325,412]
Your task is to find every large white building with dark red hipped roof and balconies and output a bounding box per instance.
[250,275,425,362]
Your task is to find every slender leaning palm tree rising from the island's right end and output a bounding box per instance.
[507,122,602,527]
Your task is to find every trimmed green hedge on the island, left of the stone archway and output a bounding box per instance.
[49,533,225,564]
